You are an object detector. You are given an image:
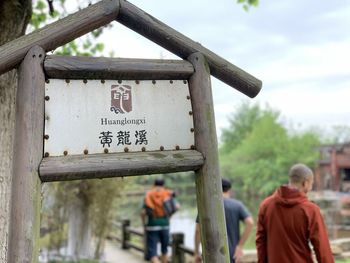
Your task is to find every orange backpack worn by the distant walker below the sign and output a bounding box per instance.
[145,188,177,217]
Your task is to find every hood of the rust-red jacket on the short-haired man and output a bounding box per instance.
[274,185,308,207]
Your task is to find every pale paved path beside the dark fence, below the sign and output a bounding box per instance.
[104,241,147,263]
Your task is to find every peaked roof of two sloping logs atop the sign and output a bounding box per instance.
[0,0,262,98]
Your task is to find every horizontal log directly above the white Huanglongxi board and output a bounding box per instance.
[44,56,194,80]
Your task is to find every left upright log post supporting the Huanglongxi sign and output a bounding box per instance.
[8,46,45,262]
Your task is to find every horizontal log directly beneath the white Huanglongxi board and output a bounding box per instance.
[39,150,203,182]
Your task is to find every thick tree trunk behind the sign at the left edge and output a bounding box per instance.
[0,0,32,262]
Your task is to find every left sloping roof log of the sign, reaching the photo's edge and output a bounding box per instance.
[0,0,119,74]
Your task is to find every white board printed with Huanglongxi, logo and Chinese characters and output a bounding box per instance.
[44,79,194,156]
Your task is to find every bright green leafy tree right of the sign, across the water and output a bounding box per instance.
[220,103,320,198]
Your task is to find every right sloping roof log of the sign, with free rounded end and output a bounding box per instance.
[117,0,262,98]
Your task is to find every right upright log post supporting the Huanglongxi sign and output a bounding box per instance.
[188,52,230,263]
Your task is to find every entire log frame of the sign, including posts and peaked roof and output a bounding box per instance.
[0,0,262,262]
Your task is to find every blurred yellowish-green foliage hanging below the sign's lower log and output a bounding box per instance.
[40,178,125,258]
